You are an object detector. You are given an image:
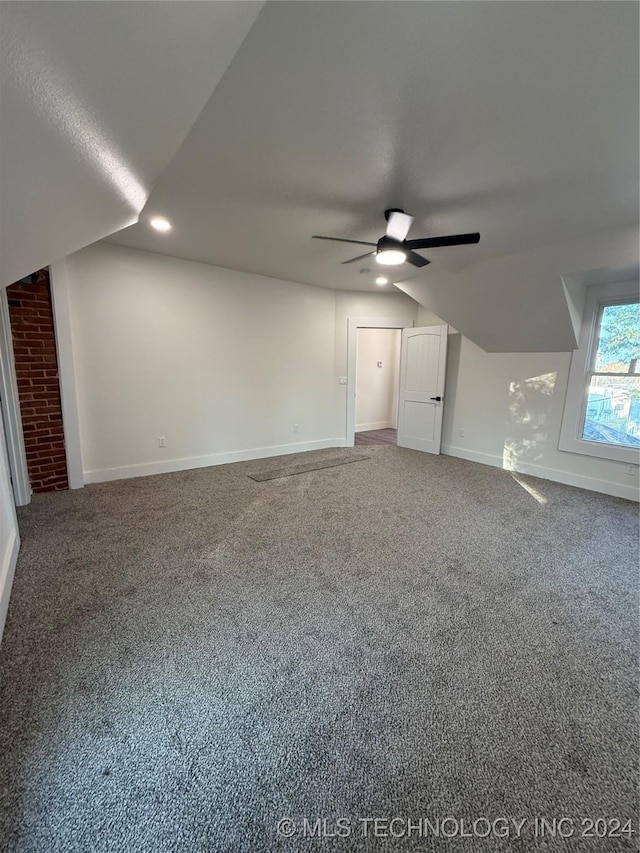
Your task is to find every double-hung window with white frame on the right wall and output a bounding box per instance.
[559,282,640,464]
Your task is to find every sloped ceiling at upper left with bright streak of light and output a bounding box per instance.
[0,2,262,285]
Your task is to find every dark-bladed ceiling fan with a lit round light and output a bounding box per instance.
[313,207,480,267]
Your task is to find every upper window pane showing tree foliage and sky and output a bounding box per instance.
[594,302,640,373]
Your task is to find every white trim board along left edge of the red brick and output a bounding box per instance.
[0,287,32,506]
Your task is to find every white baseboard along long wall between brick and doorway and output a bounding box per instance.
[83,438,347,484]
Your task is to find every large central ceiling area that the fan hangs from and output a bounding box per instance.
[109,2,638,290]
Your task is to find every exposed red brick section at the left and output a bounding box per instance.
[7,270,68,492]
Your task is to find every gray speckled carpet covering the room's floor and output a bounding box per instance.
[0,447,638,853]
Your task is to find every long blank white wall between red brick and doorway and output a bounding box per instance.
[67,244,344,482]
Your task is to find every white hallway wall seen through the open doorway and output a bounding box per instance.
[355,329,400,432]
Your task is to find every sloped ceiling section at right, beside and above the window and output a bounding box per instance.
[398,226,639,352]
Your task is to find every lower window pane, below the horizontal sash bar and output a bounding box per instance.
[582,376,640,447]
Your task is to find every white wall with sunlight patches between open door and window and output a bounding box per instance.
[442,334,638,500]
